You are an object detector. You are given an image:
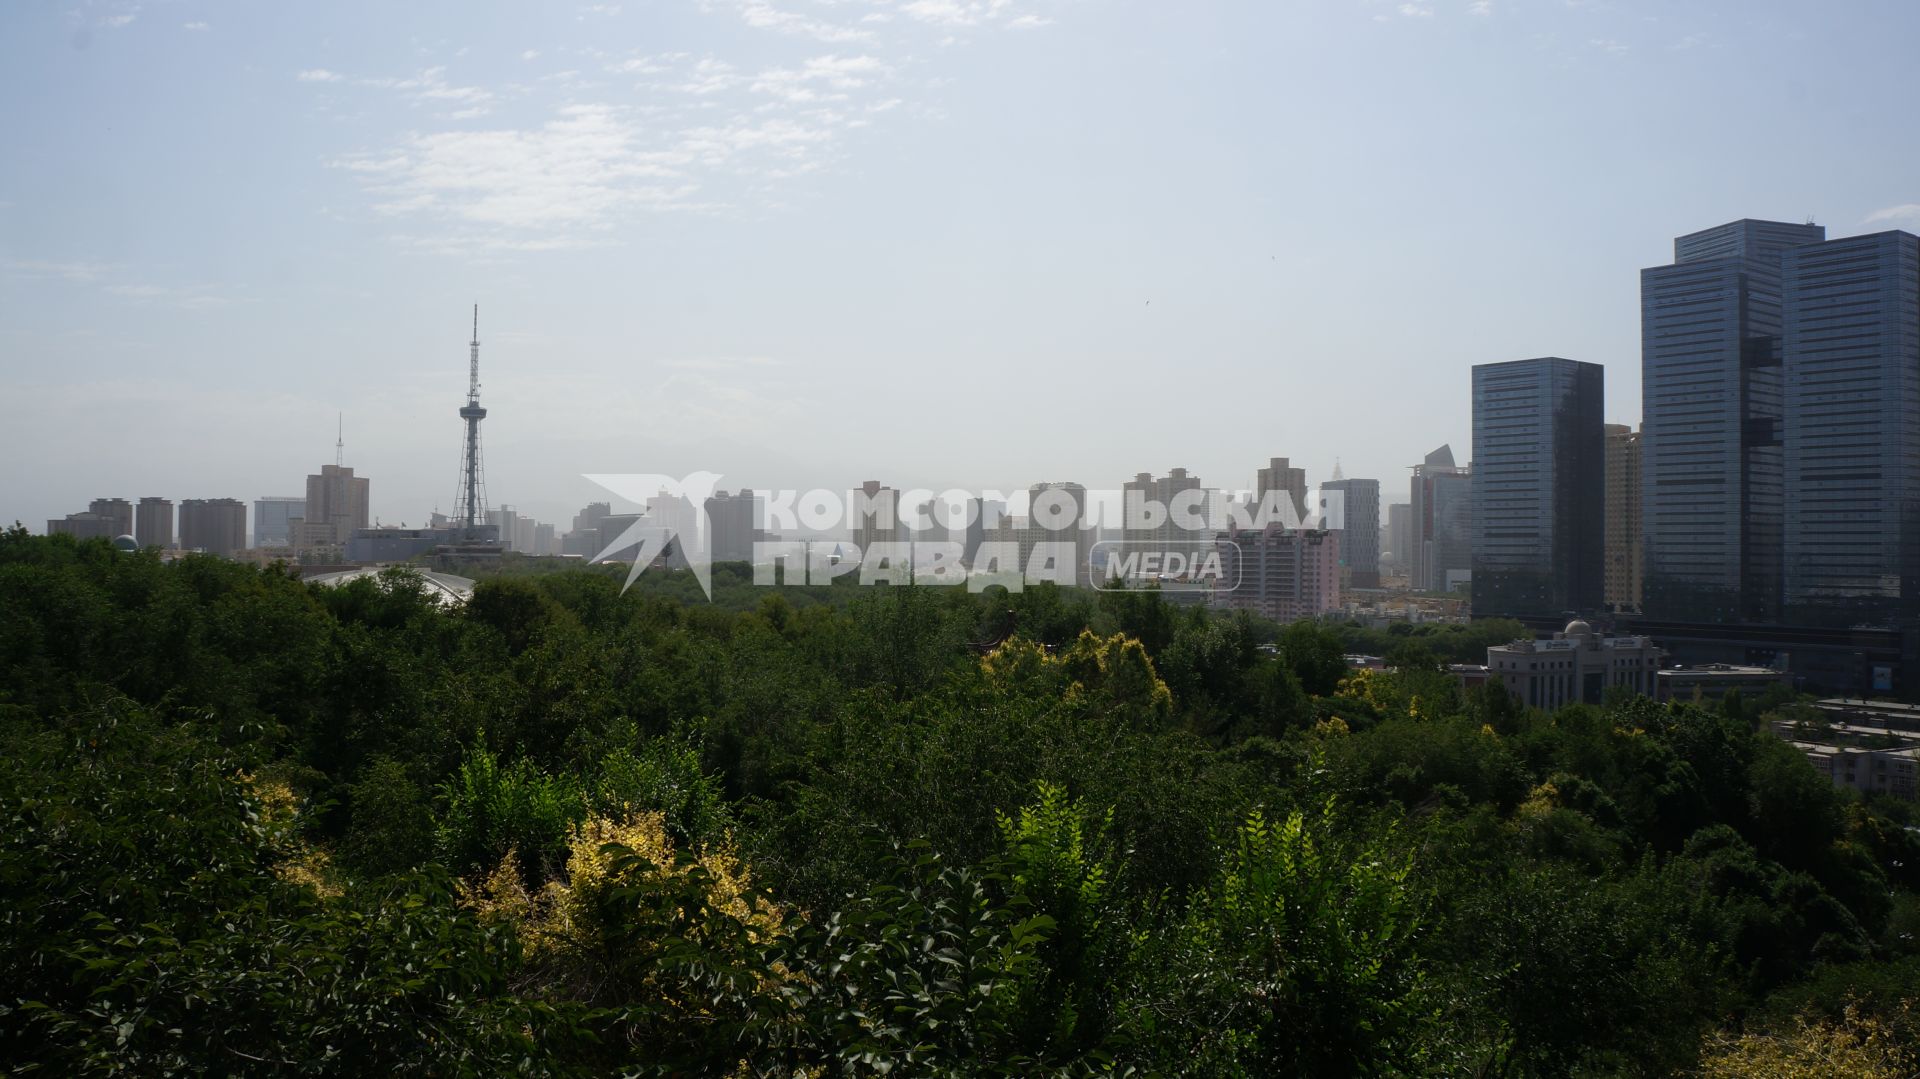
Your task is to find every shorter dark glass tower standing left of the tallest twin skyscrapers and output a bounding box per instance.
[1471,355,1607,616]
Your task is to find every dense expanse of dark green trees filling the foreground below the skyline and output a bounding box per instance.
[0,528,1920,1077]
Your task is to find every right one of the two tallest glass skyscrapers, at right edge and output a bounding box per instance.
[1784,232,1920,626]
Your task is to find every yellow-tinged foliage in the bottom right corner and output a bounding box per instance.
[1699,1002,1920,1079]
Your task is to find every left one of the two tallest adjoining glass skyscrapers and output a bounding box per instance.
[1640,221,1826,622]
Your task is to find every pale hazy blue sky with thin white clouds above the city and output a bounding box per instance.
[0,0,1920,530]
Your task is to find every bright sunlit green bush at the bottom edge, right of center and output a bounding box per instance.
[1119,806,1430,1075]
